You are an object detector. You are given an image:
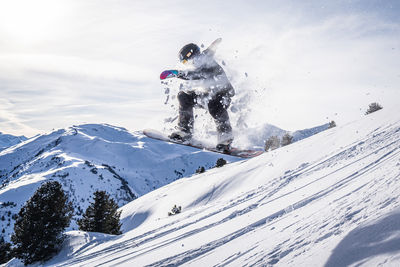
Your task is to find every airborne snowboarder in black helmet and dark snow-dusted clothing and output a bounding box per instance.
[161,39,235,151]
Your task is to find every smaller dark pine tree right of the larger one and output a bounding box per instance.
[78,191,121,235]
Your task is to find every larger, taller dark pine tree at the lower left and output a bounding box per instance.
[11,181,73,264]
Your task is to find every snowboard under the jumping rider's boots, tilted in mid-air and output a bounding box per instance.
[143,129,264,158]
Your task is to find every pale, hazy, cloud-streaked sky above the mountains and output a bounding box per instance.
[0,0,400,137]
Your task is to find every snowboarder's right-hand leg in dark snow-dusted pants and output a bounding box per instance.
[208,93,233,146]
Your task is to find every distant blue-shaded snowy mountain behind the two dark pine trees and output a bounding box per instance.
[0,124,238,243]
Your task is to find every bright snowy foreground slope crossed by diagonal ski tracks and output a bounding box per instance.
[39,110,400,266]
